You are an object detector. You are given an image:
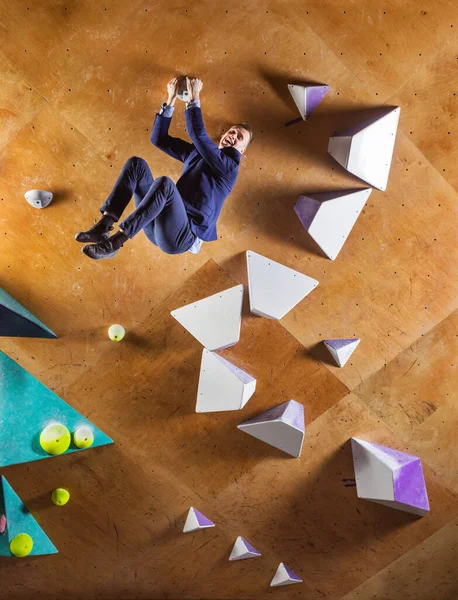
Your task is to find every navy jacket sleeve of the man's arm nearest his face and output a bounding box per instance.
[185,106,238,176]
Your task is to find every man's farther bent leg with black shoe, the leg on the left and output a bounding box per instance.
[75,156,154,242]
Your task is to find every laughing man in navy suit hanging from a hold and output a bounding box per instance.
[76,77,252,260]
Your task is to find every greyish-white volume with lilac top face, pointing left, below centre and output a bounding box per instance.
[237,400,305,458]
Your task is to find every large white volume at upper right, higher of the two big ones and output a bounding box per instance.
[328,106,401,191]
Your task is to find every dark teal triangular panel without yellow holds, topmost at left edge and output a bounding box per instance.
[0,288,57,338]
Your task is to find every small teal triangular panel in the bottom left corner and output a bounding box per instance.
[0,477,57,556]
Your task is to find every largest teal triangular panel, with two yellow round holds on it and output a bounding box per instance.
[0,352,113,467]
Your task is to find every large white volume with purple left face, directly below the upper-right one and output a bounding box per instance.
[294,188,372,260]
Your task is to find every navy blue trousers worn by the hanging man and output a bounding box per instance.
[100,156,196,254]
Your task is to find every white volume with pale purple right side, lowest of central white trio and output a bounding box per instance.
[196,348,256,412]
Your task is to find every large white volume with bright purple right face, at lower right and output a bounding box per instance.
[351,438,429,516]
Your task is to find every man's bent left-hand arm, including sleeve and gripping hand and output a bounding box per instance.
[150,77,194,162]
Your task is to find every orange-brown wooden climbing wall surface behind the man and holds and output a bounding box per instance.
[0,0,458,600]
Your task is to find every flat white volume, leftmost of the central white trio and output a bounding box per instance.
[170,285,243,350]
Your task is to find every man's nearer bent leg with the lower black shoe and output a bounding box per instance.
[83,177,195,260]
